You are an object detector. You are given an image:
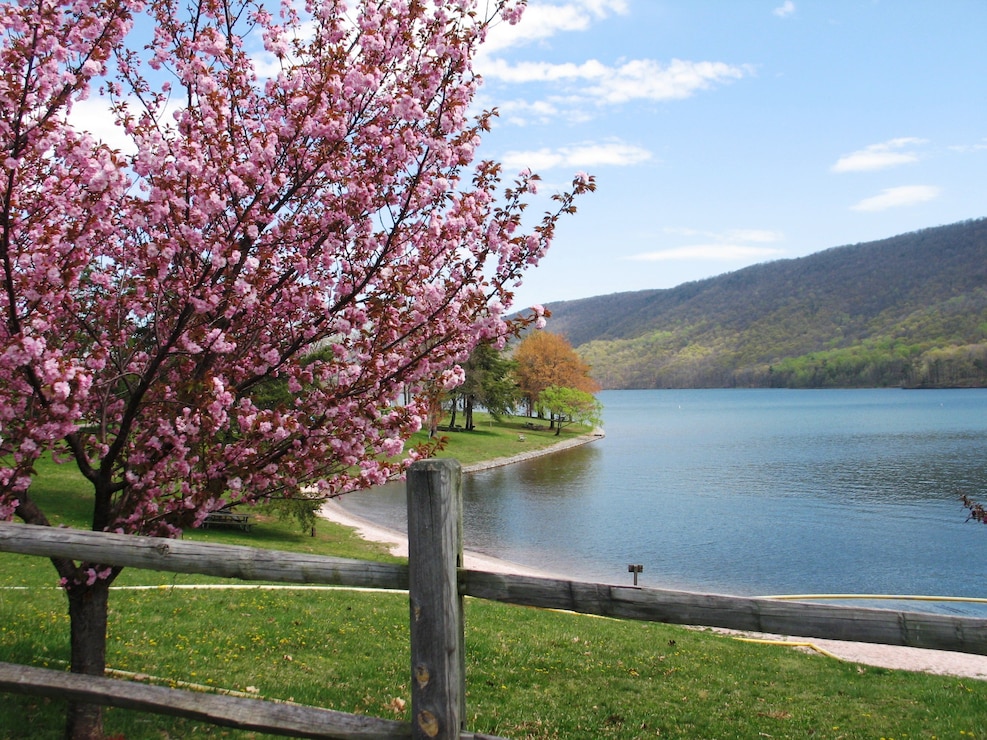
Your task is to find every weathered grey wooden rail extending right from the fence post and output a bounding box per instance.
[459,570,987,655]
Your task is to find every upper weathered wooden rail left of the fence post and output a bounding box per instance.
[0,522,408,590]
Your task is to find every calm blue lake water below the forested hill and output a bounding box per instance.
[344,389,987,614]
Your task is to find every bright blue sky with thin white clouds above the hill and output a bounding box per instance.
[477,0,987,308]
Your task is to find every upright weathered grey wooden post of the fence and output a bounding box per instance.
[408,459,466,740]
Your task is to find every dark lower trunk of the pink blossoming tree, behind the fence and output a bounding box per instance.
[65,580,111,740]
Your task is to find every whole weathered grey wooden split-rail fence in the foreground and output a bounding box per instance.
[0,460,987,739]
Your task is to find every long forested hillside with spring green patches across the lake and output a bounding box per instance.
[548,219,987,388]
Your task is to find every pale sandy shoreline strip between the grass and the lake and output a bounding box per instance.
[320,434,987,680]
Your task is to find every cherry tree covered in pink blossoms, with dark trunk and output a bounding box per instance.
[0,0,594,737]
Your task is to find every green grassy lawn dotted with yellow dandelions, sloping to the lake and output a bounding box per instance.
[0,414,987,740]
